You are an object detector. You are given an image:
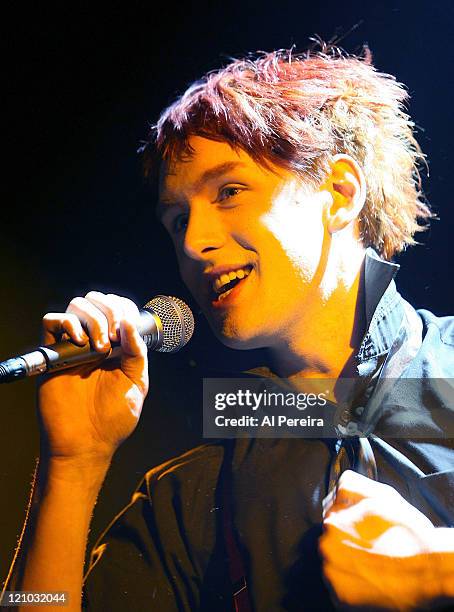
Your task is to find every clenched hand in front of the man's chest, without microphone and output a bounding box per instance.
[320,470,454,610]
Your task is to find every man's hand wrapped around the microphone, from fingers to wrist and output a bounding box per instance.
[39,291,148,465]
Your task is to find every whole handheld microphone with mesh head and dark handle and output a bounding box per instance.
[0,295,194,383]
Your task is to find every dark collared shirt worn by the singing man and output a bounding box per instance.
[85,252,454,612]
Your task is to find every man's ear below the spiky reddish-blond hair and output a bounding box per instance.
[323,153,366,234]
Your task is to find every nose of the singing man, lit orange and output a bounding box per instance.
[184,205,225,259]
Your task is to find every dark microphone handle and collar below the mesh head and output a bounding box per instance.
[0,310,163,383]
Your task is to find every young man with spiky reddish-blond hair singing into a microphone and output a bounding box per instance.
[7,47,454,612]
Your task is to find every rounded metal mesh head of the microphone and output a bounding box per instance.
[144,295,194,353]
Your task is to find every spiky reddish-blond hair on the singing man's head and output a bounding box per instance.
[145,47,432,259]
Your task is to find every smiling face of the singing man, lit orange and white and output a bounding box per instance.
[159,136,326,349]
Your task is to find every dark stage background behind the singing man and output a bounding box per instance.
[0,0,454,576]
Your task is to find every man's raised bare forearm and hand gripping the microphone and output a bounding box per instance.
[11,291,148,612]
